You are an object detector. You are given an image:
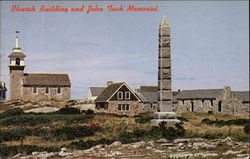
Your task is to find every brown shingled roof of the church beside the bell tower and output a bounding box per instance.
[22,73,71,87]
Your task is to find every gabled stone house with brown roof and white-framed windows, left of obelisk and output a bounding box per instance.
[95,82,142,115]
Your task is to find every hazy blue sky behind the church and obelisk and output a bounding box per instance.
[0,1,249,99]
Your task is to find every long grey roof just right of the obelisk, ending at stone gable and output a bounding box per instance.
[175,89,223,99]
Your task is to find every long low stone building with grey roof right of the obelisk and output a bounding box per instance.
[174,86,250,114]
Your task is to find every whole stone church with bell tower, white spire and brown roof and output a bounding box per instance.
[8,32,71,101]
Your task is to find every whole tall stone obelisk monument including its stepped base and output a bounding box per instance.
[151,16,180,125]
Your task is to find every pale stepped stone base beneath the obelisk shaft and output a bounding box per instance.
[150,112,180,125]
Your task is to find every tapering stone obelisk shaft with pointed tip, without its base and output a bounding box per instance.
[158,16,172,112]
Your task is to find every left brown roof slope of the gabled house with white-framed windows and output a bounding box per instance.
[95,82,124,102]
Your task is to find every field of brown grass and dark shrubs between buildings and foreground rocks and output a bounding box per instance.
[0,102,249,156]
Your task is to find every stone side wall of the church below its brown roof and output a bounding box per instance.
[21,87,71,101]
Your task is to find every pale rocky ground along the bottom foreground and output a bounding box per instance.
[12,137,250,159]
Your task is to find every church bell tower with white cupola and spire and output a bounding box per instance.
[8,31,26,100]
